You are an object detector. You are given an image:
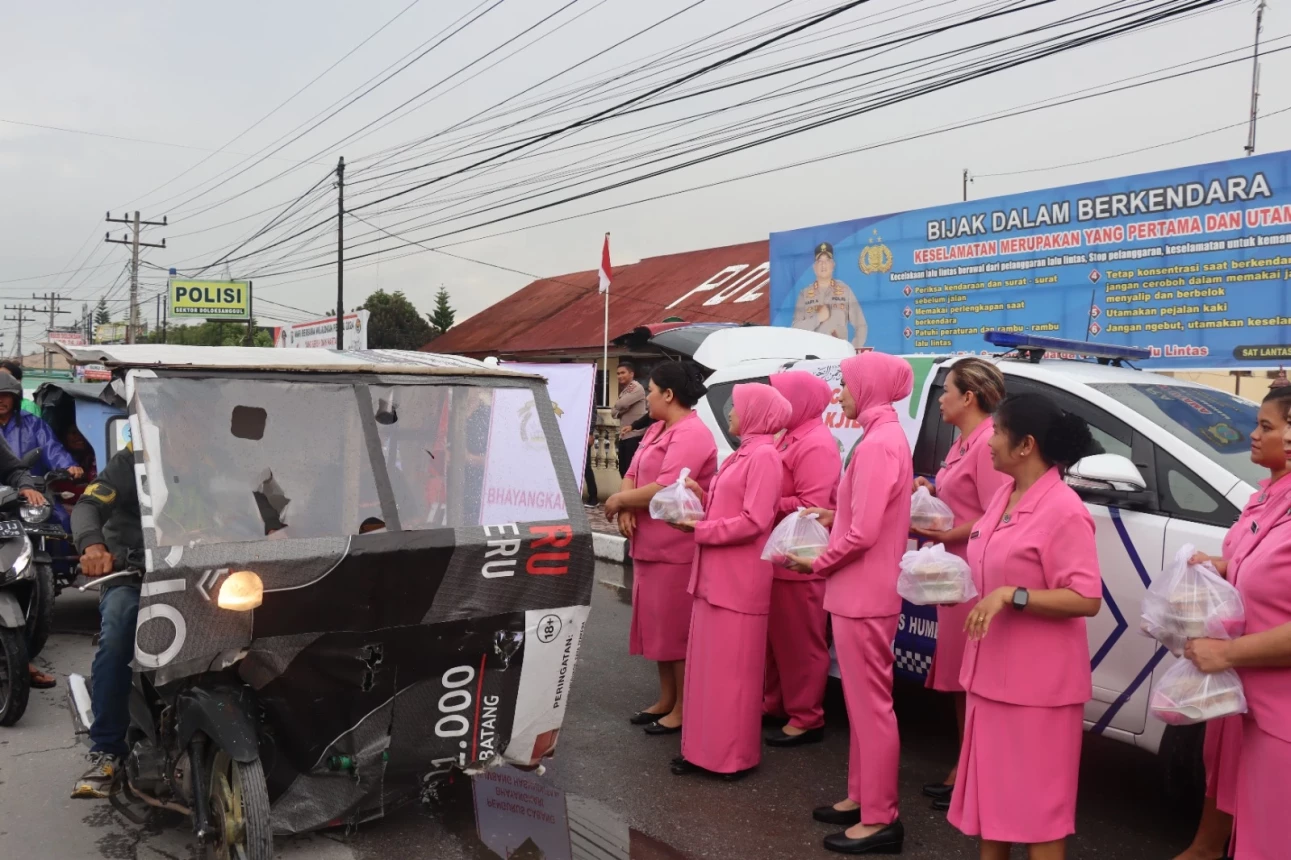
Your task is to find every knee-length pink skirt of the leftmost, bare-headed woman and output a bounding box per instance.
[627,560,695,662]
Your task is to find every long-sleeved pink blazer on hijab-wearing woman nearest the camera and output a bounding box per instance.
[813,407,914,619]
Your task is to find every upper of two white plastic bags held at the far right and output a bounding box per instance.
[1139,544,1246,657]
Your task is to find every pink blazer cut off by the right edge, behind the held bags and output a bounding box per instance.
[1228,498,1291,742]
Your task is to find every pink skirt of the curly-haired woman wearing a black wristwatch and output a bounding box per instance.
[948,692,1084,845]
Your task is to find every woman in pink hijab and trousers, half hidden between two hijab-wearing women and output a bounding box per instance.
[762,371,843,746]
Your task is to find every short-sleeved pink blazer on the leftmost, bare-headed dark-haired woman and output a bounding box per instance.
[627,412,718,564]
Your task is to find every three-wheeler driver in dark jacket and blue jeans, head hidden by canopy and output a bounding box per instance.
[72,445,143,798]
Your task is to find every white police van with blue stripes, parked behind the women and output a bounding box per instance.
[666,327,1265,781]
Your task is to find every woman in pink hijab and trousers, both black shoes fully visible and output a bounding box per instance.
[798,353,914,854]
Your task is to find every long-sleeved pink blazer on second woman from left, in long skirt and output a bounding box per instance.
[689,438,781,615]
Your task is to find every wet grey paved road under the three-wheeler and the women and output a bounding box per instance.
[0,568,1193,860]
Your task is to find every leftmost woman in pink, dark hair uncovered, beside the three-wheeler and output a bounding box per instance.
[605,362,718,735]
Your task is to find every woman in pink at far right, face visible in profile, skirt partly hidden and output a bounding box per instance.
[1175,386,1291,860]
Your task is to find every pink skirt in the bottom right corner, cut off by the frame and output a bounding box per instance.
[1233,714,1291,860]
